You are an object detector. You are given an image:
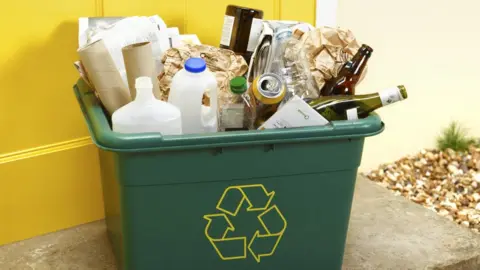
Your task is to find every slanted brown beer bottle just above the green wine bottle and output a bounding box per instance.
[320,44,373,96]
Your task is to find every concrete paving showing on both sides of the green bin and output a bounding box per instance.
[0,177,480,270]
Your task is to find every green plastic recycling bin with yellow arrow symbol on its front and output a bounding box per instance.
[74,80,384,270]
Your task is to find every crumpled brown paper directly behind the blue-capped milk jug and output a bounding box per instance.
[158,44,248,105]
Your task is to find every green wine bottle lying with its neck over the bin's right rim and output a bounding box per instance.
[308,85,408,121]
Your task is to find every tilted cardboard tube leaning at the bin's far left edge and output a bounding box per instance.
[78,40,131,114]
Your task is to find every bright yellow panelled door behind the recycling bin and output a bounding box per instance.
[0,0,315,245]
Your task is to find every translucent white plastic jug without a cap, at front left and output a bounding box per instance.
[112,77,182,135]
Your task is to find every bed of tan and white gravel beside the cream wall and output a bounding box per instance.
[364,146,480,233]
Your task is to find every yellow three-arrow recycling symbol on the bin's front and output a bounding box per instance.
[203,184,287,262]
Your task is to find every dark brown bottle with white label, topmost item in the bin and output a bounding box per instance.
[220,5,263,64]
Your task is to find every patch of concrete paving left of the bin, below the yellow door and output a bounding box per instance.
[0,221,117,270]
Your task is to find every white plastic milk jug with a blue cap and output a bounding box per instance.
[168,58,218,134]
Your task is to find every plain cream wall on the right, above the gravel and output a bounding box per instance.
[337,0,480,171]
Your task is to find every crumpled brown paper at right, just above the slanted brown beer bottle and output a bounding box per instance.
[286,26,367,92]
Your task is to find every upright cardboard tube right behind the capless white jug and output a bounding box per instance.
[122,41,161,99]
